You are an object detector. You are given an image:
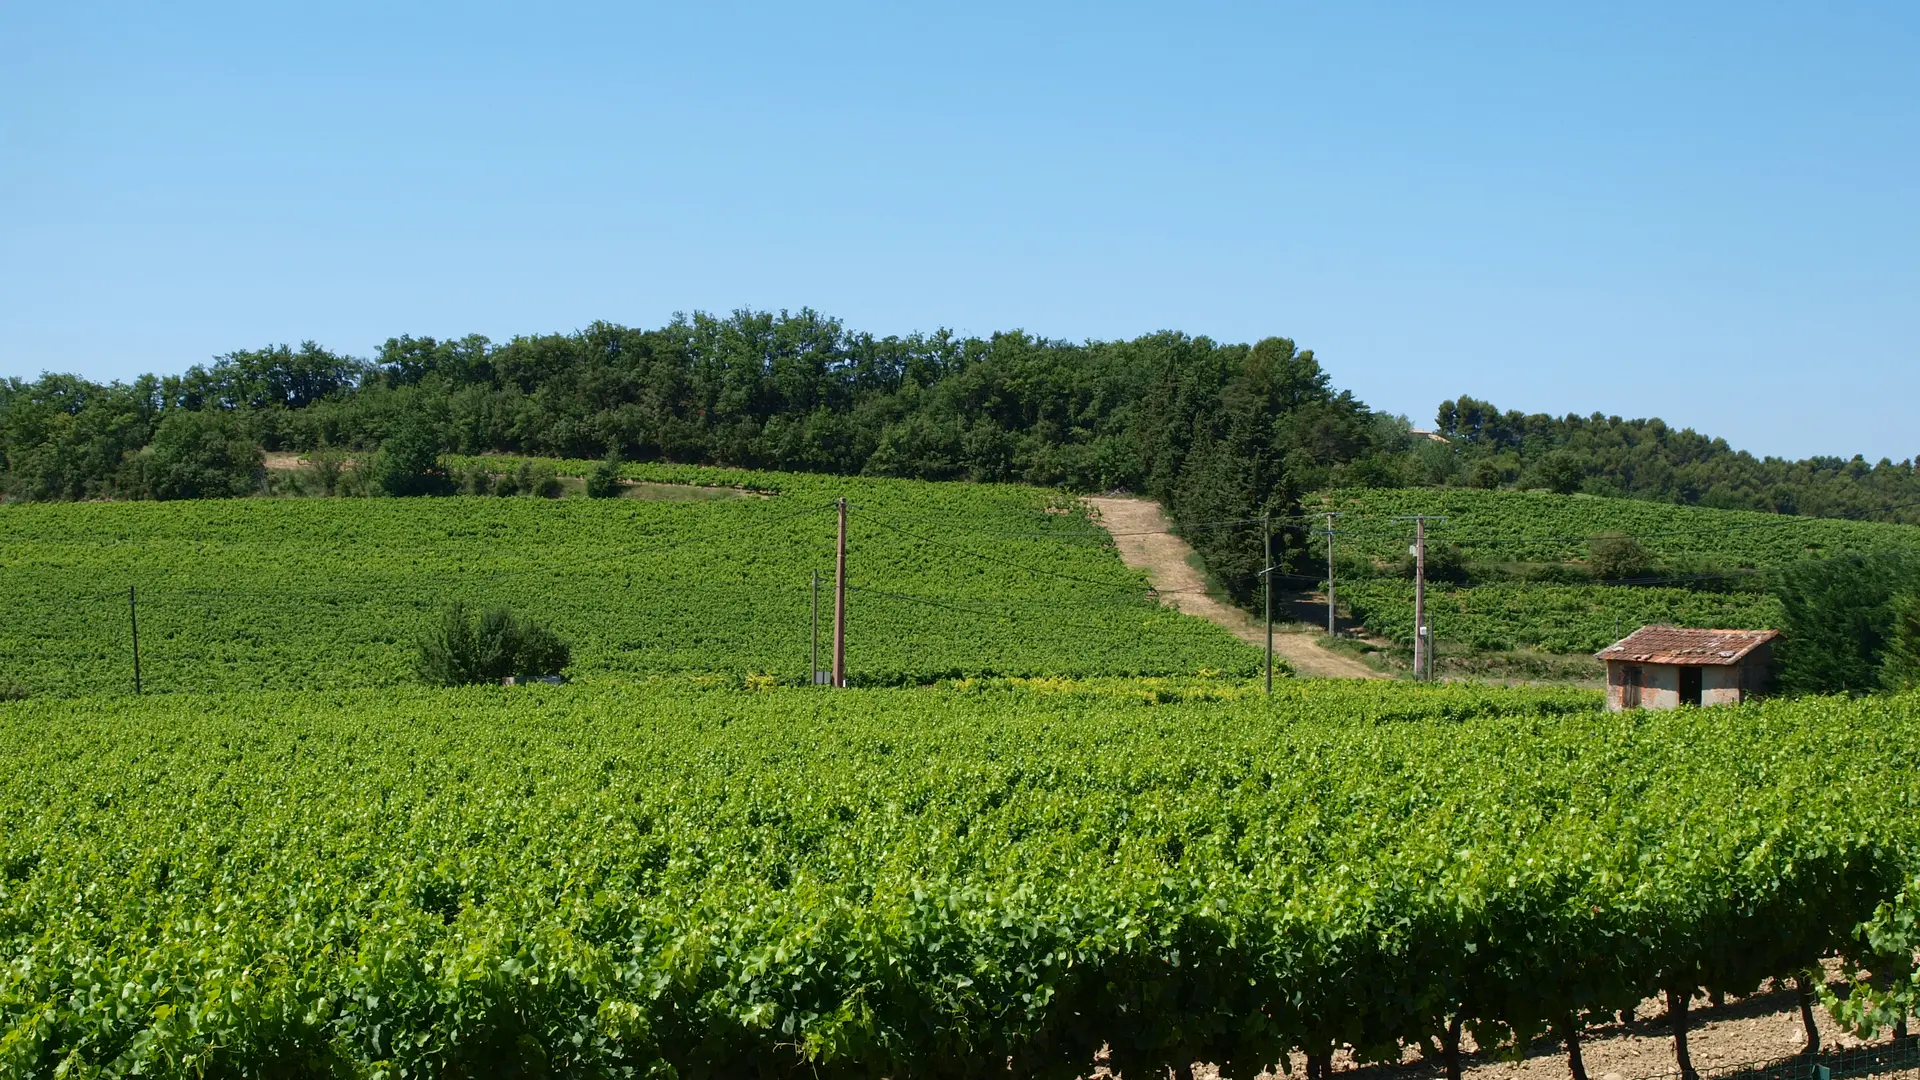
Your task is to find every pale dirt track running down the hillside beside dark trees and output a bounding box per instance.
[1087,498,1384,678]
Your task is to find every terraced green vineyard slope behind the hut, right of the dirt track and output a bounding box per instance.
[1302,488,1920,653]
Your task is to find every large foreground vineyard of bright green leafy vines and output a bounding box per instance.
[0,680,1920,1078]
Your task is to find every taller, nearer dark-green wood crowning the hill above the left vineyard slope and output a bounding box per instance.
[0,311,1377,598]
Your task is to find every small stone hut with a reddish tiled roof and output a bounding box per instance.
[1594,626,1780,709]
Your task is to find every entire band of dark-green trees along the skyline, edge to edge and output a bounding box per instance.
[0,309,1920,600]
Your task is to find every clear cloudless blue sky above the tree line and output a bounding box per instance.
[0,0,1920,457]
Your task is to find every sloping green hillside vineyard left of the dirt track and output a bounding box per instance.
[0,467,1258,694]
